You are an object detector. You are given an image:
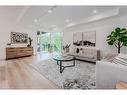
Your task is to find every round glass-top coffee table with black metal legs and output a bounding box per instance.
[53,55,75,73]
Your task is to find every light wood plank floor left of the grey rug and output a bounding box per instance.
[0,56,58,89]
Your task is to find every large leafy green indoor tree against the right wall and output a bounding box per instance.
[106,27,127,53]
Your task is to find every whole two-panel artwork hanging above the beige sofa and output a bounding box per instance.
[73,31,96,47]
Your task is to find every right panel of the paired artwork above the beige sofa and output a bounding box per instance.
[83,31,96,47]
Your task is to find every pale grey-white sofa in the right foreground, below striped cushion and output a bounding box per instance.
[96,61,127,89]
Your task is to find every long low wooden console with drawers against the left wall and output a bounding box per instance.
[6,47,33,59]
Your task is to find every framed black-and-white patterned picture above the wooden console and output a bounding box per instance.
[11,32,28,44]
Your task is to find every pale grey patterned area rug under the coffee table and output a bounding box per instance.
[31,59,96,89]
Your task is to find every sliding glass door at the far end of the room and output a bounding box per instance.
[37,32,62,53]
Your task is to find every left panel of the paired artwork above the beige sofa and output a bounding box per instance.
[73,32,83,46]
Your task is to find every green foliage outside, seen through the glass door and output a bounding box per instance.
[38,32,61,51]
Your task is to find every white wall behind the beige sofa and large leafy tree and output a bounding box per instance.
[63,16,127,53]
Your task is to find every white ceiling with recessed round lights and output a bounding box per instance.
[0,6,127,31]
